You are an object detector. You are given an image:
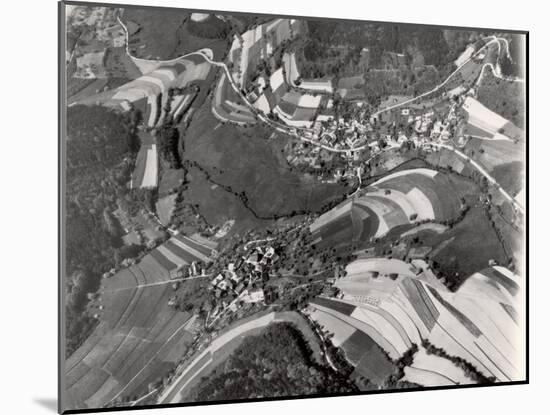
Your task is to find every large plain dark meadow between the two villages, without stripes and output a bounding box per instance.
[181,100,346,221]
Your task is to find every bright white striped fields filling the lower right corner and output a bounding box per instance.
[309,258,523,386]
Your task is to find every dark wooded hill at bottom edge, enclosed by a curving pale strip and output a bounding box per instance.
[194,323,357,401]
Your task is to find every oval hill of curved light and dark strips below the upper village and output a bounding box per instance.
[310,168,476,250]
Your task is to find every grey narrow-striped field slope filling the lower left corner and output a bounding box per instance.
[65,235,218,409]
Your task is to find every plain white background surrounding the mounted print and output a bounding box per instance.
[0,0,550,415]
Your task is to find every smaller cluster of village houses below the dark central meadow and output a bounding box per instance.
[210,246,278,307]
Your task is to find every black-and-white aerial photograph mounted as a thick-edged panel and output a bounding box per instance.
[60,2,528,411]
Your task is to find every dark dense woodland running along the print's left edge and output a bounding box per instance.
[65,105,139,355]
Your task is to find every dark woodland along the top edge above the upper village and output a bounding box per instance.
[300,20,475,94]
